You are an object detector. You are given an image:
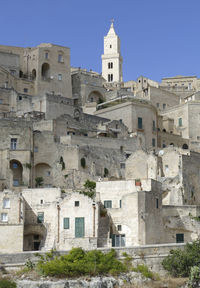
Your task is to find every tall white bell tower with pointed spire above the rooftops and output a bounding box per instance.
[101,19,123,83]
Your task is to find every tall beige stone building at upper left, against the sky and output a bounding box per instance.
[0,43,72,98]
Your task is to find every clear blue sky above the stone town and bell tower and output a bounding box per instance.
[0,0,200,81]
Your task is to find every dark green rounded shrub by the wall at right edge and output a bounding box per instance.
[162,240,200,277]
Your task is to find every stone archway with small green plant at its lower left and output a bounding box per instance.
[35,163,52,187]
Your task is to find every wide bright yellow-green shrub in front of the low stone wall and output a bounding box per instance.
[37,248,127,277]
